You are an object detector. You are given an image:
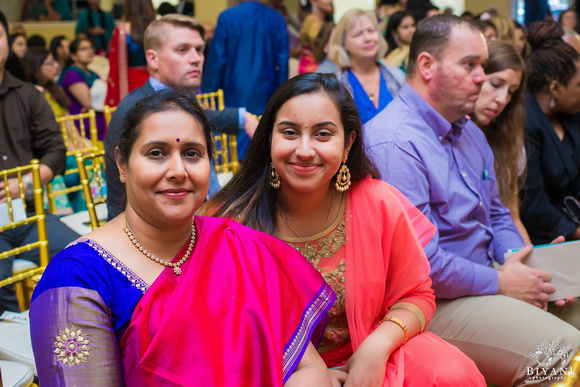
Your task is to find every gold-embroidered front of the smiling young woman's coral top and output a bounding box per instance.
[289,217,350,353]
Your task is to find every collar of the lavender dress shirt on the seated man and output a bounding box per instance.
[399,82,467,141]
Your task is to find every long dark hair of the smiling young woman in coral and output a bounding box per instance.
[202,73,380,234]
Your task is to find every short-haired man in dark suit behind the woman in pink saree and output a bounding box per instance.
[104,14,258,219]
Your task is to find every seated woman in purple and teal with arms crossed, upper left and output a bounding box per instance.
[58,39,107,140]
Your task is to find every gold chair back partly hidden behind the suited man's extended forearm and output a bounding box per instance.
[196,89,239,173]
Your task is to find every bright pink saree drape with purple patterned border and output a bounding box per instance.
[120,217,335,387]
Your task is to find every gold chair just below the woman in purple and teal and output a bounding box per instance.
[46,109,99,215]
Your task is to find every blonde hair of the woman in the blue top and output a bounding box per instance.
[328,9,389,69]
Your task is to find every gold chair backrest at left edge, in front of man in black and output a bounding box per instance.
[0,159,49,287]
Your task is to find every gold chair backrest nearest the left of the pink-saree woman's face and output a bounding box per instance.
[76,150,107,230]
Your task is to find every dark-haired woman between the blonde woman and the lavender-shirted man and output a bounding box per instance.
[385,11,416,72]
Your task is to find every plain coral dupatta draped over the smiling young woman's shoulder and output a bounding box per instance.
[345,178,436,386]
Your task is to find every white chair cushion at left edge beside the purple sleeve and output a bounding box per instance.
[0,321,37,376]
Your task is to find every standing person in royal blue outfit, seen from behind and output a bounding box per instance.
[203,0,290,159]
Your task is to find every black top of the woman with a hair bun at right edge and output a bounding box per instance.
[520,94,580,244]
